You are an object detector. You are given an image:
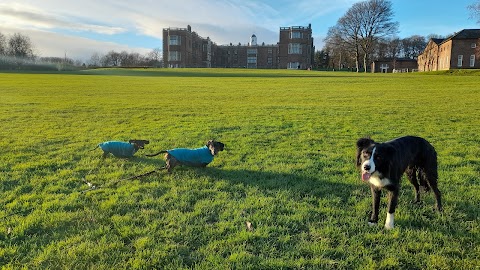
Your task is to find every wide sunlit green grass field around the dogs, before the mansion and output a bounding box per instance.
[0,69,480,269]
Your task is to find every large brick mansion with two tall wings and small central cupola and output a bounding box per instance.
[163,25,315,69]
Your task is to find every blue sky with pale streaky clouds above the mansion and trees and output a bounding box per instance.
[0,0,480,62]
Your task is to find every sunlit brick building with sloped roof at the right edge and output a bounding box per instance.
[418,29,480,71]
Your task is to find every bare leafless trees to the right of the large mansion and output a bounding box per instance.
[315,0,470,72]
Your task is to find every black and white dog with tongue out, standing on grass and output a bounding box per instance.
[356,136,442,229]
